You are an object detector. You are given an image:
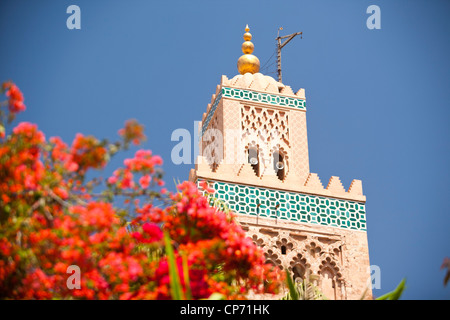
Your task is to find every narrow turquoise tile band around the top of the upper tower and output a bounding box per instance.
[200,87,306,137]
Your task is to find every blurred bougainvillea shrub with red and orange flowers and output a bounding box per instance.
[0,82,281,299]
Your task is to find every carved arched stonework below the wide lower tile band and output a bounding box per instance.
[242,219,352,300]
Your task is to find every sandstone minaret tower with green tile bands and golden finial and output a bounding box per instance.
[189,26,371,299]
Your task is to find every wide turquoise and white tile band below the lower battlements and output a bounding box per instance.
[199,180,366,231]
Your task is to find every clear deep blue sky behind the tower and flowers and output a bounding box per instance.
[0,0,450,299]
